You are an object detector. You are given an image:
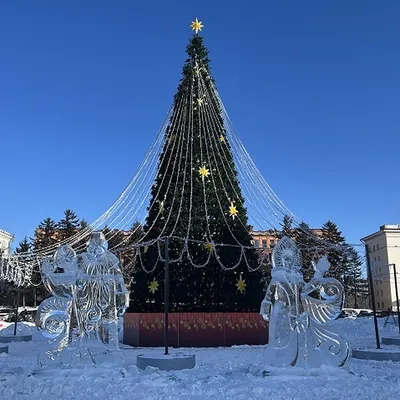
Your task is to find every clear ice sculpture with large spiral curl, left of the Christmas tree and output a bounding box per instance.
[36,232,129,363]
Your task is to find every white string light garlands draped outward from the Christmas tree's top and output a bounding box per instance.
[0,18,363,293]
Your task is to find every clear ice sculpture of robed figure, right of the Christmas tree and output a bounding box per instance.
[260,237,349,368]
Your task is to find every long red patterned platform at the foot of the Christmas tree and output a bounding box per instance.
[123,313,268,347]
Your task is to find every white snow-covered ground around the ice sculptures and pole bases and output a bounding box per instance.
[0,318,400,400]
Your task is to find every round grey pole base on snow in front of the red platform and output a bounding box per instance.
[136,352,196,371]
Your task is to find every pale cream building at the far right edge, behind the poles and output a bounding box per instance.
[361,224,400,311]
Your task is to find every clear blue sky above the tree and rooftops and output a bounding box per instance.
[0,0,400,245]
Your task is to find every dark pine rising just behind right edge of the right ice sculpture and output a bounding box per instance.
[322,221,348,284]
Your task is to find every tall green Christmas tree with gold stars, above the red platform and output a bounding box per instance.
[130,19,264,312]
